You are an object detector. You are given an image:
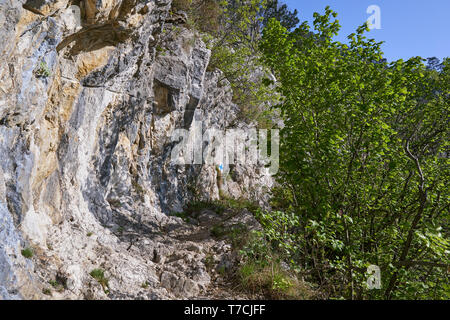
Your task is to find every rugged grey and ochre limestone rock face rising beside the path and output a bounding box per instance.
[0,0,272,299]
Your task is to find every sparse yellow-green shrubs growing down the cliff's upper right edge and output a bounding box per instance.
[210,0,276,126]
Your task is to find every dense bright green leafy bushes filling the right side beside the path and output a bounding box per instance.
[260,7,450,299]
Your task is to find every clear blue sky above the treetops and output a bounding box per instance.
[281,0,450,61]
